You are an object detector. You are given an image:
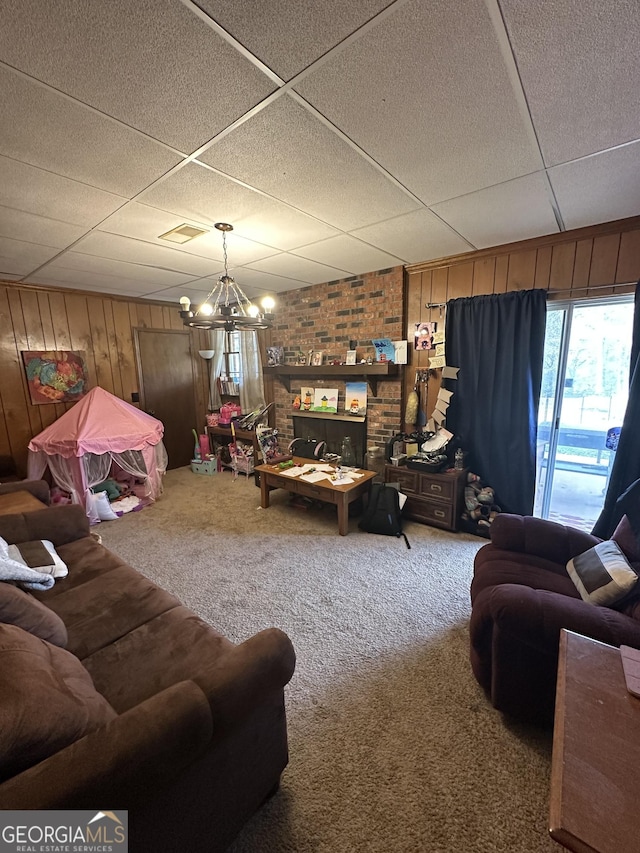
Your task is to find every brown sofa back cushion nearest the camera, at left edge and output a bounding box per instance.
[0,625,117,781]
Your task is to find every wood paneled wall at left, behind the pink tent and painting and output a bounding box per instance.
[0,281,215,476]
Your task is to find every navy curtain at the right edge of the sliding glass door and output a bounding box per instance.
[592,281,640,539]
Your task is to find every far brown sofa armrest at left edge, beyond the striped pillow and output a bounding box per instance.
[0,504,91,546]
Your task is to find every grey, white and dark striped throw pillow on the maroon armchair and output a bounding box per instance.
[567,539,638,607]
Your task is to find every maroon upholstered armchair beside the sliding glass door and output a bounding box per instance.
[469,513,640,724]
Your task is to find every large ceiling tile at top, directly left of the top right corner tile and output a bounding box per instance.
[295,0,542,204]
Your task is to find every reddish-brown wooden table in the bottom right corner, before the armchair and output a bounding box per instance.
[549,629,640,853]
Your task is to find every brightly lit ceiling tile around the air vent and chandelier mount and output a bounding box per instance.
[98,202,278,265]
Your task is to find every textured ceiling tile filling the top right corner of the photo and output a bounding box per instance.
[500,0,640,165]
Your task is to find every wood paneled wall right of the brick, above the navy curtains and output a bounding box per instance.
[403,217,640,422]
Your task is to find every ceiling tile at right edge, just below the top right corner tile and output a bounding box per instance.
[549,143,640,228]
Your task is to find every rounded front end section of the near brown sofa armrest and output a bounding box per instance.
[194,628,296,732]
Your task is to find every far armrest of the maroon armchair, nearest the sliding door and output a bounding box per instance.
[491,512,602,565]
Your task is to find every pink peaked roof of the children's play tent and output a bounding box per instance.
[29,387,164,459]
